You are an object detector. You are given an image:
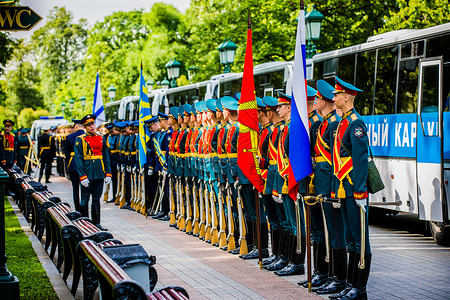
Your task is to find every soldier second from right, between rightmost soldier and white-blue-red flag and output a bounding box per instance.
[311,80,347,294]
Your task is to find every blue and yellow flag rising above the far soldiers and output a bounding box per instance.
[138,68,152,168]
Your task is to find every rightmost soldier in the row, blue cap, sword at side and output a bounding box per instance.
[331,76,372,299]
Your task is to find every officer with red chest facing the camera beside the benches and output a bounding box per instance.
[74,114,111,230]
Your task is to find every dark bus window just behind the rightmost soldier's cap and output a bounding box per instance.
[354,51,375,115]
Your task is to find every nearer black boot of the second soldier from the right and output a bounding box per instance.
[316,249,347,294]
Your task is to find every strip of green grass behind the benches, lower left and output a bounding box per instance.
[5,198,58,300]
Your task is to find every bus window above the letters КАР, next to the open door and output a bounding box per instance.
[397,59,419,113]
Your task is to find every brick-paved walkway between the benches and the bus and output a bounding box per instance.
[31,177,450,299]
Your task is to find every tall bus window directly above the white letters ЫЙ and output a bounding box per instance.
[374,46,398,115]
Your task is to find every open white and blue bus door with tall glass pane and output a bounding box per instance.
[416,58,443,222]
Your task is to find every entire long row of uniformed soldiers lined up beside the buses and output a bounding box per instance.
[105,77,371,299]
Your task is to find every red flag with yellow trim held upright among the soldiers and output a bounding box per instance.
[238,16,264,193]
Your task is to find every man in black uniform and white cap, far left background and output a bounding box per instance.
[38,125,56,183]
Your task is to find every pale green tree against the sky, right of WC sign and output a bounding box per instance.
[32,7,87,106]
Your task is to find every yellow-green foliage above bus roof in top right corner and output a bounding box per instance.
[378,0,450,33]
